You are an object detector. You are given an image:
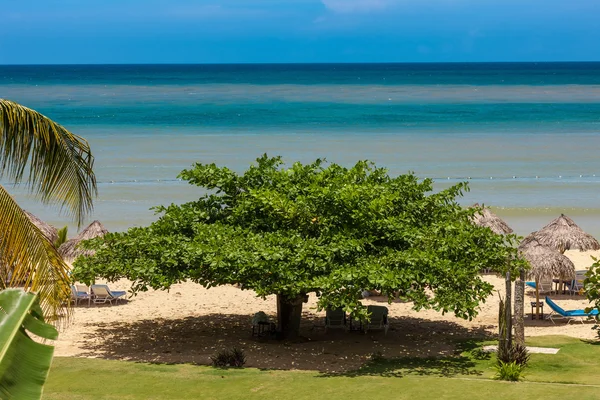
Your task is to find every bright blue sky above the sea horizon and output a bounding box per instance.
[0,0,600,64]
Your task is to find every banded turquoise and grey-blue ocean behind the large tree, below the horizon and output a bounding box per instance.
[0,63,600,237]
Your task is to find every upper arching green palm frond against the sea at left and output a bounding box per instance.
[0,99,97,225]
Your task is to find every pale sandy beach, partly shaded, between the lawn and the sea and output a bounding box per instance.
[55,251,600,372]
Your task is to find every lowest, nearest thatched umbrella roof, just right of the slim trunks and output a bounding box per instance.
[519,239,575,281]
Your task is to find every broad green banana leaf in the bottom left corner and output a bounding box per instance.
[0,289,58,400]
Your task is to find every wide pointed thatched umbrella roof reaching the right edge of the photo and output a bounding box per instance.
[521,214,600,253]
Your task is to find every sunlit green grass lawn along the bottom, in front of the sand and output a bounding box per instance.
[44,337,600,400]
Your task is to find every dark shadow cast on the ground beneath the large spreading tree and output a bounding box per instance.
[78,314,488,376]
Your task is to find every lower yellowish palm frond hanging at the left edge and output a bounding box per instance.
[0,186,71,321]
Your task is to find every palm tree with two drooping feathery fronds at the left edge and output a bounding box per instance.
[0,99,96,320]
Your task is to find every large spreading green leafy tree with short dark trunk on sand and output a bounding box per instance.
[74,155,518,337]
